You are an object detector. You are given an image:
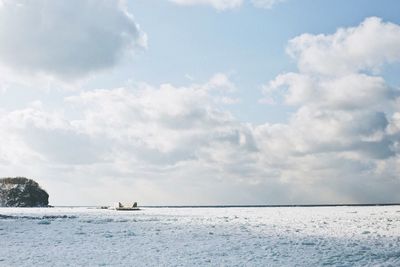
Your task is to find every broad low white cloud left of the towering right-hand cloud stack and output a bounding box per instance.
[0,74,257,204]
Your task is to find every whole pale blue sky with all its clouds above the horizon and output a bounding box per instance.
[0,0,400,205]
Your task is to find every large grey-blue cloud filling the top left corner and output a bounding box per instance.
[0,0,146,79]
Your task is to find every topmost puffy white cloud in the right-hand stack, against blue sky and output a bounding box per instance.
[287,17,400,75]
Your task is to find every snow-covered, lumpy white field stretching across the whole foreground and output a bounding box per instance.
[0,206,400,266]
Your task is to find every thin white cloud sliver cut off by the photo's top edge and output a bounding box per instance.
[170,0,285,10]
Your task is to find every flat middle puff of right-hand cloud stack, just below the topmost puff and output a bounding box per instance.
[263,73,399,109]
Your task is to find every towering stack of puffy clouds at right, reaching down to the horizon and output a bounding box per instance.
[256,17,400,202]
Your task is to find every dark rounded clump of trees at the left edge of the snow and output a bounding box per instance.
[0,177,49,207]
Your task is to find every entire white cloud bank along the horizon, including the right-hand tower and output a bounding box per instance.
[0,17,400,204]
